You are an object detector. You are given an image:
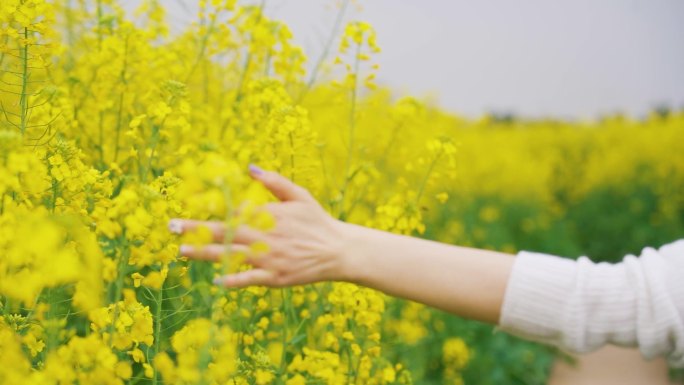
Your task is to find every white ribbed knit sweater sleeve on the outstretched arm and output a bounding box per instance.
[499,240,684,366]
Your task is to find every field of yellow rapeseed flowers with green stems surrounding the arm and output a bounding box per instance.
[0,0,684,385]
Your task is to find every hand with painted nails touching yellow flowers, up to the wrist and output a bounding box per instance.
[169,166,346,287]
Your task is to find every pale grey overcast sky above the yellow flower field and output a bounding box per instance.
[136,0,684,118]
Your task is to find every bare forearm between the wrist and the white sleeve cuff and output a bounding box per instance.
[341,225,514,324]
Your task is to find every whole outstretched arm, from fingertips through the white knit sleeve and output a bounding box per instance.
[174,166,684,365]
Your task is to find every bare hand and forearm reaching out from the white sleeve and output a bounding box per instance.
[169,167,514,323]
